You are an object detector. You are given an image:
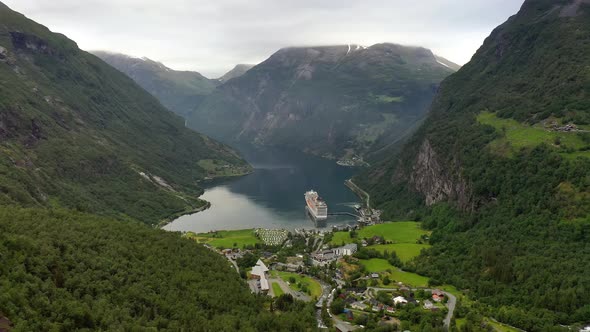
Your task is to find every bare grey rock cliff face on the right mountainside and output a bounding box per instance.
[409,139,473,210]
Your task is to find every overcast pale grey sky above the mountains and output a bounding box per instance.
[0,0,523,78]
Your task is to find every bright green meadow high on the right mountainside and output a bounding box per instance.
[477,112,590,157]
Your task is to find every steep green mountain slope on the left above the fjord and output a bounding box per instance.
[0,2,248,223]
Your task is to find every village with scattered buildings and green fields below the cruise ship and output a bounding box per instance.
[191,222,464,331]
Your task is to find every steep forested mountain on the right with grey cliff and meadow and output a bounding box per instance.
[356,0,590,331]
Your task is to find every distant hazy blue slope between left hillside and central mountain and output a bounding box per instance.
[92,51,218,116]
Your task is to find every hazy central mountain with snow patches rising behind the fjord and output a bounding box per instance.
[187,44,453,158]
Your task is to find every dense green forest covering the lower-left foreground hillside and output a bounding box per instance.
[0,207,315,331]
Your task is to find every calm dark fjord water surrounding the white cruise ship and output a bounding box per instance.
[164,148,358,232]
